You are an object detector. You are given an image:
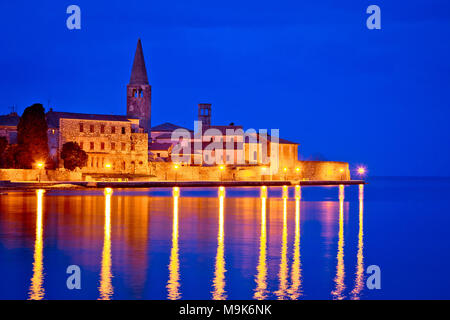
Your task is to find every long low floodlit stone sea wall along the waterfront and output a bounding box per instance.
[0,161,350,181]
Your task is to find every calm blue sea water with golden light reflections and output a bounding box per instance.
[0,178,450,299]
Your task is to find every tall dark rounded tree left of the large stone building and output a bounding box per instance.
[17,103,48,169]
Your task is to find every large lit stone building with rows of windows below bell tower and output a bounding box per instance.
[46,111,148,175]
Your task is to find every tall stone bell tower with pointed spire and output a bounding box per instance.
[127,39,152,133]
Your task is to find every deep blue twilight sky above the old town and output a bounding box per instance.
[0,0,450,176]
